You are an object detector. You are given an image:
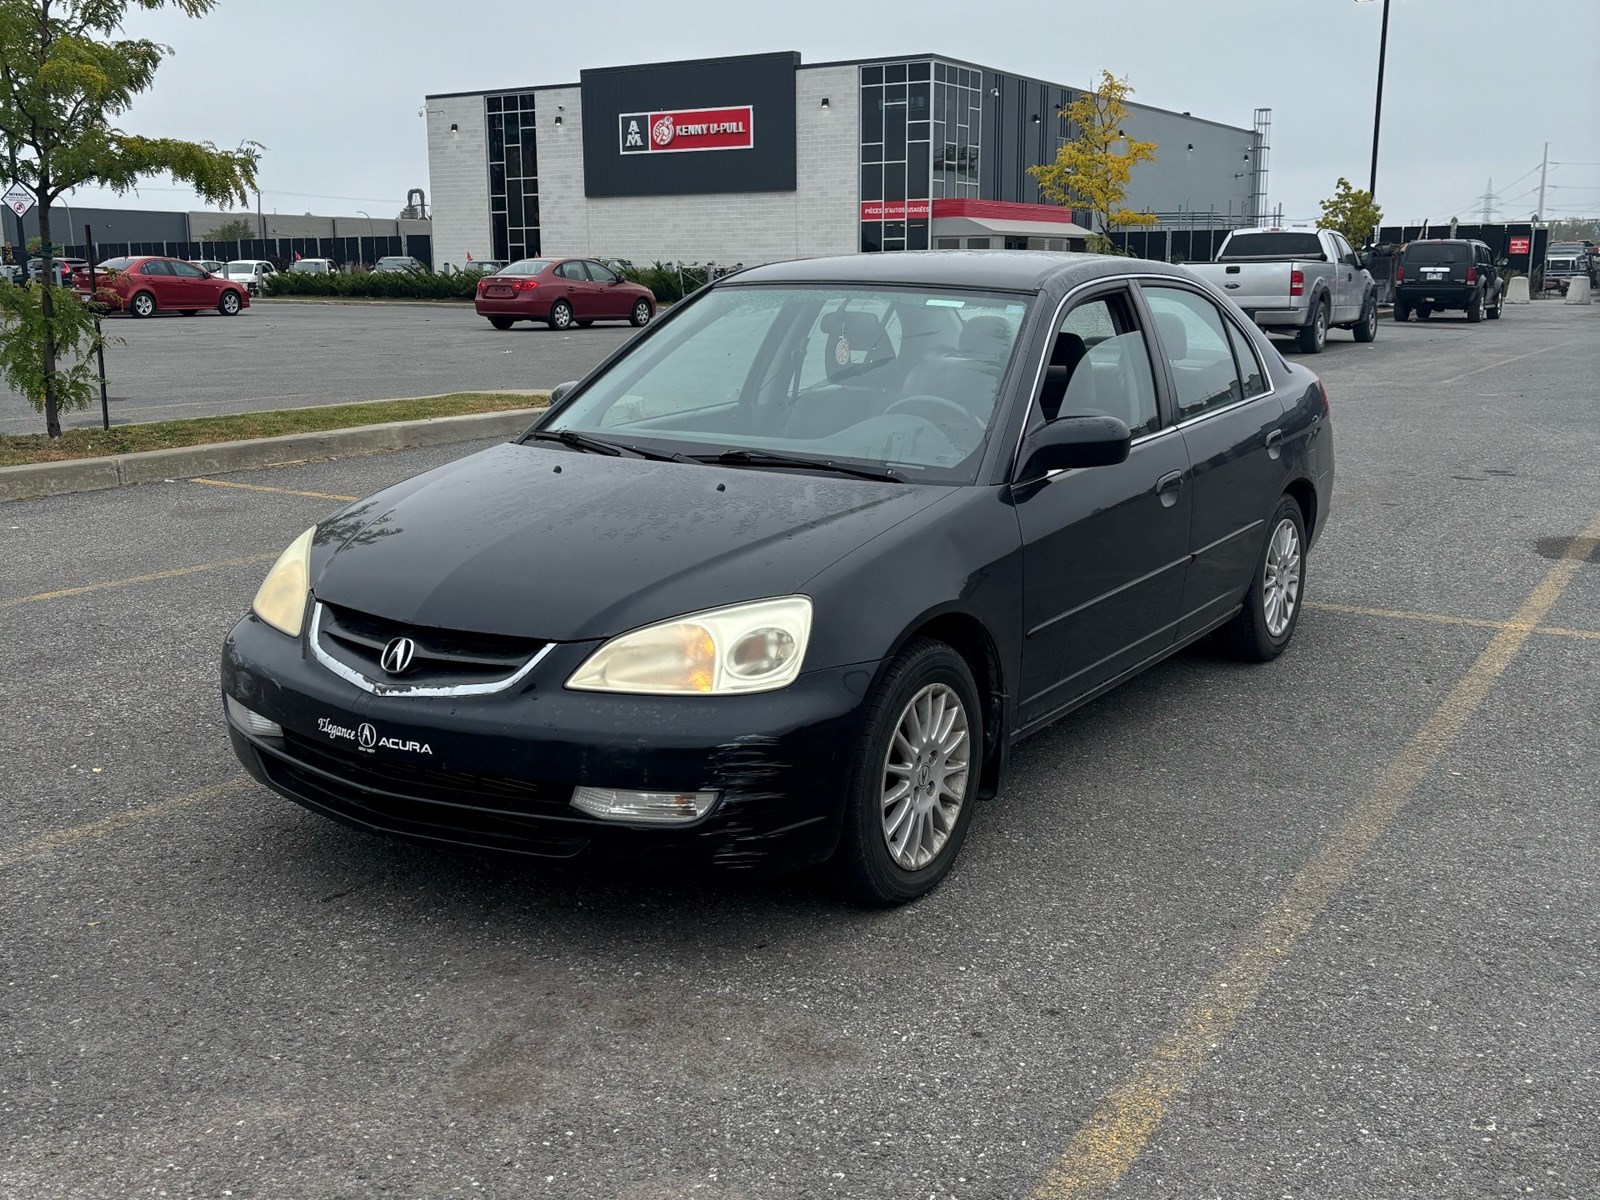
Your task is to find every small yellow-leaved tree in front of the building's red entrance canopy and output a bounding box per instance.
[1027,70,1160,253]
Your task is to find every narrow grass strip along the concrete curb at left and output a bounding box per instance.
[0,392,549,467]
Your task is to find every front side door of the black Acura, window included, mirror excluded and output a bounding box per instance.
[1013,286,1190,728]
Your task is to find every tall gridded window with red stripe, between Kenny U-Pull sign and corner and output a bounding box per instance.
[861,59,936,251]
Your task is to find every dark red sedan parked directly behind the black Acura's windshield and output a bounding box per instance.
[474,258,656,330]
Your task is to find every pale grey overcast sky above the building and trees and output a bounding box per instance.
[56,0,1600,221]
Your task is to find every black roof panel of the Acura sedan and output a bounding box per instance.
[730,250,1192,291]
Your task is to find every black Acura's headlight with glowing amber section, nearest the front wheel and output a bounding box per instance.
[566,595,811,696]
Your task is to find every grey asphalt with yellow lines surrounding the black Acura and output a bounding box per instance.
[0,304,1600,1200]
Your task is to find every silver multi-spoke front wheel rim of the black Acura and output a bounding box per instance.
[882,683,973,870]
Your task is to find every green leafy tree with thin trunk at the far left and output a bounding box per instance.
[0,0,259,437]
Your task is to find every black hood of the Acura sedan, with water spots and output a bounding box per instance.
[312,443,954,642]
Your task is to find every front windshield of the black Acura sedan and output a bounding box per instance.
[542,285,1032,483]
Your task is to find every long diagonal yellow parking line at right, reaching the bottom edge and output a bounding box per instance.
[1034,517,1600,1200]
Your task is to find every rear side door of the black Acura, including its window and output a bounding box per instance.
[1141,280,1288,638]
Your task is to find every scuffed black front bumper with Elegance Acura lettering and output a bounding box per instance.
[222,616,875,874]
